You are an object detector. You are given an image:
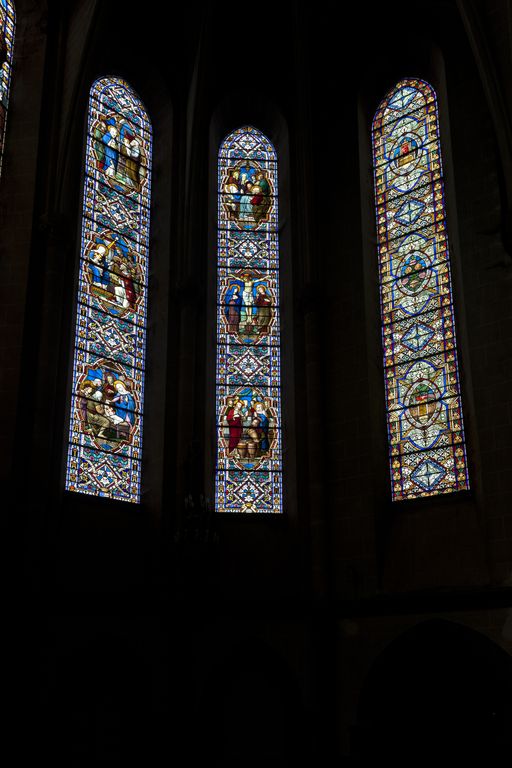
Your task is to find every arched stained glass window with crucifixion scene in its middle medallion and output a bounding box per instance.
[216,127,282,513]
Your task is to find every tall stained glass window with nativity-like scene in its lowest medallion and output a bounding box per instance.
[66,78,151,502]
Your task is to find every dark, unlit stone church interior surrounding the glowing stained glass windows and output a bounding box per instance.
[0,0,512,768]
